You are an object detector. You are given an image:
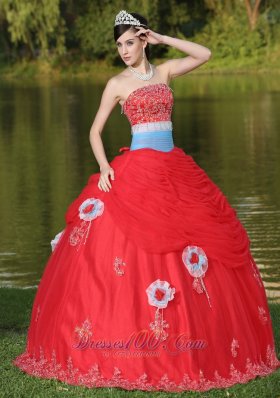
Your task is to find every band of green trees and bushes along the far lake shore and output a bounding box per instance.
[0,0,280,66]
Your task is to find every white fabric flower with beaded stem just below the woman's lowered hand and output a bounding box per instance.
[69,198,104,250]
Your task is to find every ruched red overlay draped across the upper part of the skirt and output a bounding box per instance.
[66,147,251,268]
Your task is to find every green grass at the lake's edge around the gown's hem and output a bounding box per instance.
[0,288,280,398]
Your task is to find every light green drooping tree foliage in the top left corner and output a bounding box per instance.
[1,0,65,56]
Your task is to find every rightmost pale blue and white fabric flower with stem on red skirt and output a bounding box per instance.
[182,246,211,307]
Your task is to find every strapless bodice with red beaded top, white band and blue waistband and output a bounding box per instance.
[123,83,174,152]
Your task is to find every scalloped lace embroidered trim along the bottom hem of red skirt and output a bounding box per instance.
[13,345,280,392]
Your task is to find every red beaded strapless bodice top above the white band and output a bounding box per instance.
[123,83,173,126]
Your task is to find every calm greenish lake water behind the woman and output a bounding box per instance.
[0,73,280,300]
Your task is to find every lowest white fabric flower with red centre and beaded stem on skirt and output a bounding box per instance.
[146,279,175,341]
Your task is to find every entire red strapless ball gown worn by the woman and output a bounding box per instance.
[12,84,280,391]
